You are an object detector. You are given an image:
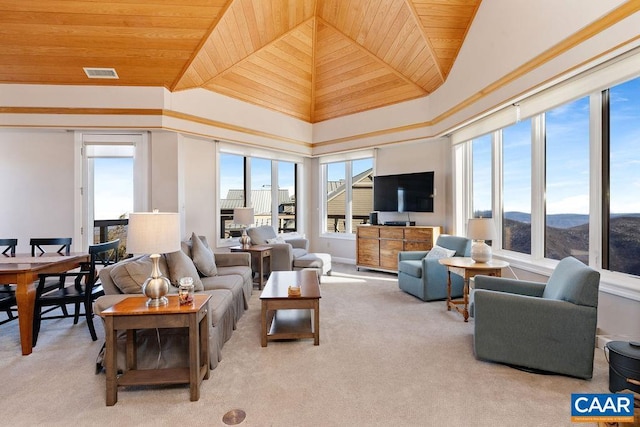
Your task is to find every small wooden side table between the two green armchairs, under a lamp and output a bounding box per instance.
[438,257,509,322]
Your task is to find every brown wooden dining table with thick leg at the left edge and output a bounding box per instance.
[0,252,89,356]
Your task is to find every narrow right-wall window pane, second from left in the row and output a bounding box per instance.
[502,119,531,254]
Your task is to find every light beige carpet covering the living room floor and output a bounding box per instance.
[0,264,608,427]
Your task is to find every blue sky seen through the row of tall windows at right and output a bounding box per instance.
[473,74,640,214]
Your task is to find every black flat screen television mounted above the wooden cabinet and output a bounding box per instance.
[373,171,434,212]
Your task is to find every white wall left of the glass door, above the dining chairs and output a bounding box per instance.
[0,129,80,253]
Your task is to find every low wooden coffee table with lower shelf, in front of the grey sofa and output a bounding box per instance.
[260,270,320,347]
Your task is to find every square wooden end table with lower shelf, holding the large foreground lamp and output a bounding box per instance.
[102,294,211,406]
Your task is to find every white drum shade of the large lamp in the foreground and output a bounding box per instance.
[127,212,180,254]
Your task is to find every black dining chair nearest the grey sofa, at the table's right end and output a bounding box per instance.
[33,239,120,346]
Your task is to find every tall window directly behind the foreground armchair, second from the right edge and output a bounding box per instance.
[544,97,589,264]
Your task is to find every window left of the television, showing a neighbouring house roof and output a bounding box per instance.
[323,158,373,233]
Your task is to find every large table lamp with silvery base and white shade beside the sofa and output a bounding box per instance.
[127,210,181,307]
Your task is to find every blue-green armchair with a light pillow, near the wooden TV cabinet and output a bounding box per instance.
[398,234,471,301]
